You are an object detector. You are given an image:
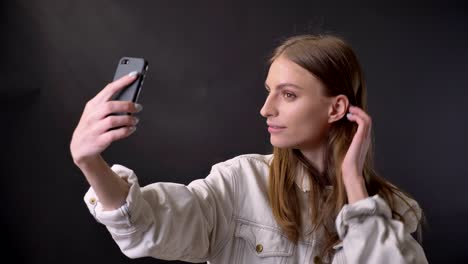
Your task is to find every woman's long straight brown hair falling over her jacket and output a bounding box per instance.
[268,35,417,258]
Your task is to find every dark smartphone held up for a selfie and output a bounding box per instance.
[111,57,148,115]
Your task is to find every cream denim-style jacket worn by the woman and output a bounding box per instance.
[84,154,427,264]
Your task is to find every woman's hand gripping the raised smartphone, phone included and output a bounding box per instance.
[70,58,148,167]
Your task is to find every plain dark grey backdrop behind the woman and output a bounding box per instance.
[0,0,468,263]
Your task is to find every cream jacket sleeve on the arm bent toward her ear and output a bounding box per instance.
[333,195,427,264]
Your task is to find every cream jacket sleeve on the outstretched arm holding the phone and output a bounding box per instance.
[84,163,235,262]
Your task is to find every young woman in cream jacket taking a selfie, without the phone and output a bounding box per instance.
[70,35,427,263]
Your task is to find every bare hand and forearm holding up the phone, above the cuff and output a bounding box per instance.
[70,72,141,210]
